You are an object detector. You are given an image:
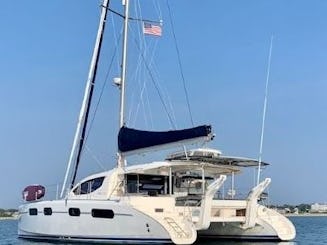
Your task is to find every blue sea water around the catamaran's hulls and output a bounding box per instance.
[0,216,327,245]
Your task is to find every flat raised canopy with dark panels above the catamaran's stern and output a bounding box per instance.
[166,149,269,167]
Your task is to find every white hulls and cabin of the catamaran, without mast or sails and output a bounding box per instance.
[18,158,295,244]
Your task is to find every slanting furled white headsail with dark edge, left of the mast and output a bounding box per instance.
[60,0,110,198]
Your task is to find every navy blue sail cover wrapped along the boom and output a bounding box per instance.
[118,125,212,153]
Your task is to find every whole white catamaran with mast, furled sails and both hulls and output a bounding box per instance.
[18,0,295,244]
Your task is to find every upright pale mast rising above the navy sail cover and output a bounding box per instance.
[118,0,129,167]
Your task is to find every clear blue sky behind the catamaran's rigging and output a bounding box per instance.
[0,0,327,208]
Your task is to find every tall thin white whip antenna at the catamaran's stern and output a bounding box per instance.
[257,35,274,185]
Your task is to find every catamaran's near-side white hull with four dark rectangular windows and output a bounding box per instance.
[18,200,171,244]
